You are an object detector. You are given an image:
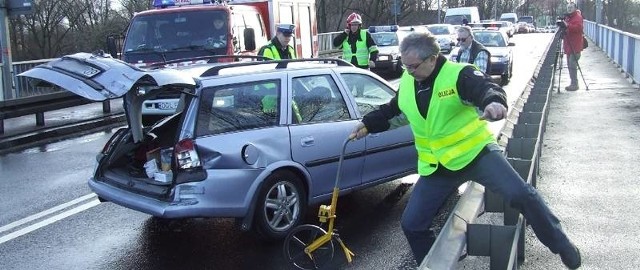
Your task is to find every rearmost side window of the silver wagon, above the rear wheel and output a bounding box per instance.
[196,80,280,136]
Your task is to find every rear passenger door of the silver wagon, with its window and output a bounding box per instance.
[289,70,364,198]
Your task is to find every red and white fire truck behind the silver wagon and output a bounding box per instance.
[107,0,318,67]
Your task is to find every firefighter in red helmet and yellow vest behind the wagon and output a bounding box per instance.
[333,13,378,69]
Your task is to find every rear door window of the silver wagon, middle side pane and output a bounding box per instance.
[292,75,351,124]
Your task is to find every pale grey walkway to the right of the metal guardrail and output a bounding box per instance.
[520,39,640,269]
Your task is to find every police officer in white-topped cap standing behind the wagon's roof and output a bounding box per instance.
[258,23,297,60]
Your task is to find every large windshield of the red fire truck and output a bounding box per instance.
[123,10,229,63]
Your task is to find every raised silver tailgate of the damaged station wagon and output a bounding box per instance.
[18,53,196,142]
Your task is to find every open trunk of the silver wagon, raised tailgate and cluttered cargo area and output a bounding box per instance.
[19,53,196,198]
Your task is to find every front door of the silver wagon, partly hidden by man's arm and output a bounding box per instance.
[341,73,417,184]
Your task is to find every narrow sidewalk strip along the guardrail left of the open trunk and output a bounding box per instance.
[0,99,126,154]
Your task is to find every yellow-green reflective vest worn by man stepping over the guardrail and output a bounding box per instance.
[398,61,495,175]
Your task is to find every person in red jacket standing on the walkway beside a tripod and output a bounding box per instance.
[562,2,584,91]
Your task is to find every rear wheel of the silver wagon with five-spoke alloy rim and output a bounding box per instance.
[254,171,307,241]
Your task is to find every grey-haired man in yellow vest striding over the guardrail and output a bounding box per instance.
[350,33,581,269]
